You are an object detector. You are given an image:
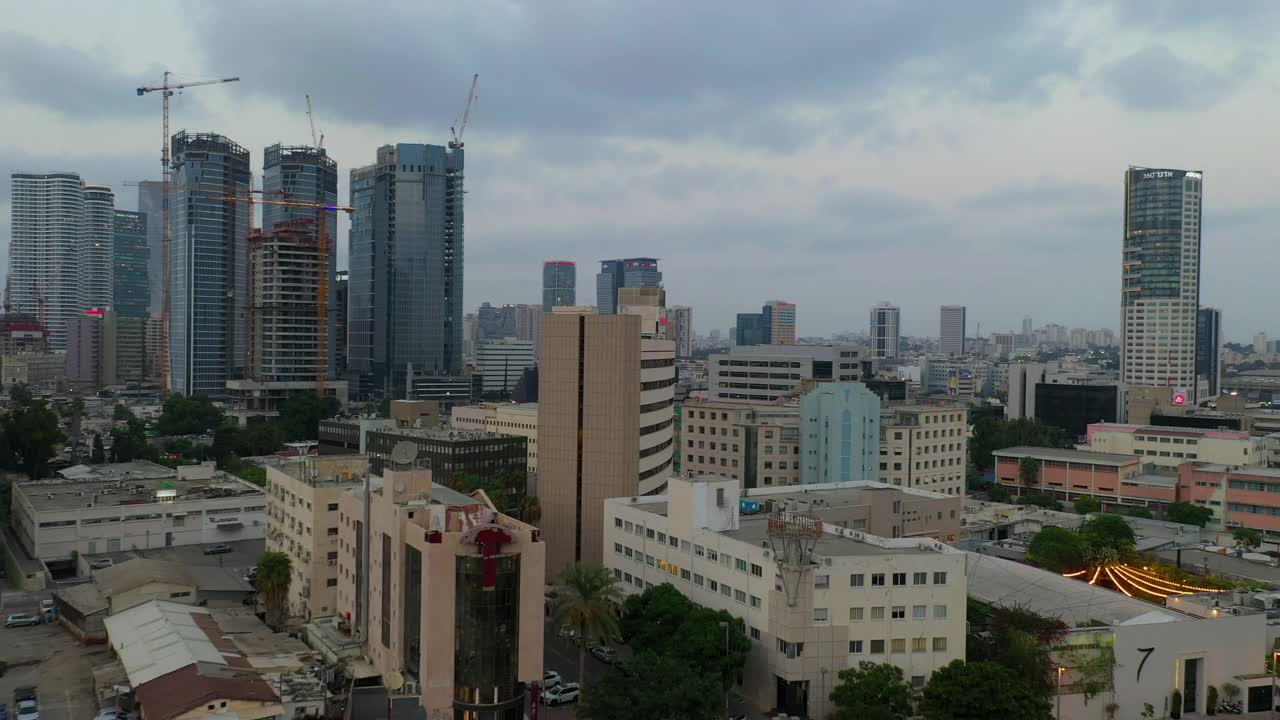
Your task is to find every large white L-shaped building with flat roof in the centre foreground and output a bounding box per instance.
[602,477,966,717]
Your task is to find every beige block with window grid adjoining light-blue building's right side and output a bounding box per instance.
[879,405,969,497]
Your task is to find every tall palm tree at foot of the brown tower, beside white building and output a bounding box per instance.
[552,562,622,685]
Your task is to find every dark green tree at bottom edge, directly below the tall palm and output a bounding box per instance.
[577,652,723,720]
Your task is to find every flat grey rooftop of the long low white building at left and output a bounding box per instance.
[17,460,262,512]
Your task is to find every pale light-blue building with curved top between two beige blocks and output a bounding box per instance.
[800,383,881,486]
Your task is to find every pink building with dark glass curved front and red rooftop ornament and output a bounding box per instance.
[334,468,547,720]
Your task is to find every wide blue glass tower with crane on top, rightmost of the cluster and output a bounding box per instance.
[347,143,465,397]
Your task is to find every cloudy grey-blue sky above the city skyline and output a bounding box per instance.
[0,0,1280,340]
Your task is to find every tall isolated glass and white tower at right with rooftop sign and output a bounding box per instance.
[1120,167,1203,404]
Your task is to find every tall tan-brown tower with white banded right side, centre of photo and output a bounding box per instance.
[538,311,676,578]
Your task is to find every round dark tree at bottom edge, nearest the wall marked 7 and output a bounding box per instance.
[920,660,1052,720]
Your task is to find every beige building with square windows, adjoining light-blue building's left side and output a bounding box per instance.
[677,398,800,489]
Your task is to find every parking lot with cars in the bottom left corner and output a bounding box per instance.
[0,625,102,720]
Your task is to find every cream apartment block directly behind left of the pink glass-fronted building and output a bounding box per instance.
[266,455,369,620]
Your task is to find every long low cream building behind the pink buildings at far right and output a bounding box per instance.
[1088,423,1266,468]
